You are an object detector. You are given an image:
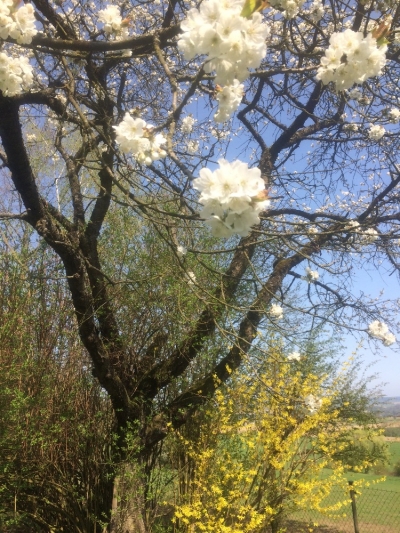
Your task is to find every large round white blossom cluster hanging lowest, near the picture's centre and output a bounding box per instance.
[193,159,270,237]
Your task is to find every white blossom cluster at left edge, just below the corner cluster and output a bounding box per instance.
[0,52,33,96]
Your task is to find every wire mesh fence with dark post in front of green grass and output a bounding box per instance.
[285,485,400,533]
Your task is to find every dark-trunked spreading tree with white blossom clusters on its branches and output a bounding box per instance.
[0,0,400,531]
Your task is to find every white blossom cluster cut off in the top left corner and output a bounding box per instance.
[0,0,37,44]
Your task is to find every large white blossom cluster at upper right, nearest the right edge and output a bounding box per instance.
[316,29,387,90]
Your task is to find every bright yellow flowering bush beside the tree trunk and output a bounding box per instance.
[170,340,382,533]
